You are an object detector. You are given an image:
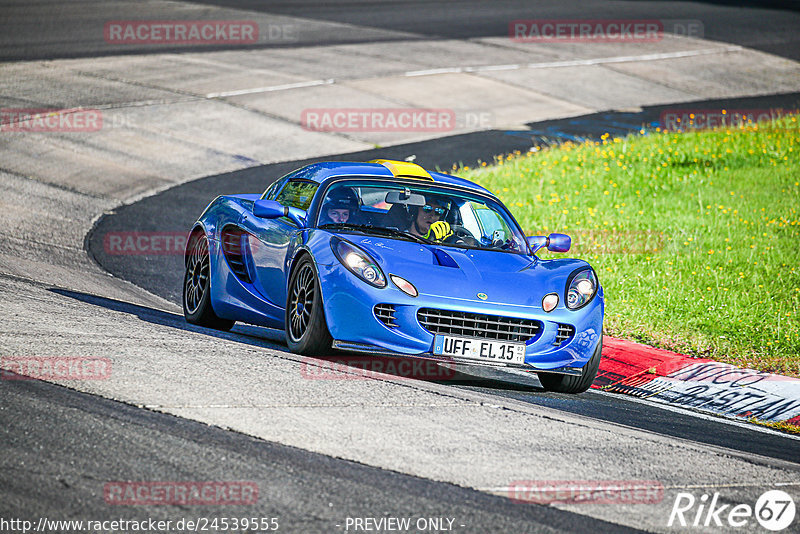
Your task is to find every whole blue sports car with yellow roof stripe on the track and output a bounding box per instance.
[183,160,603,393]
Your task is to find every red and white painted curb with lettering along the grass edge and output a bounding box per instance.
[592,337,800,427]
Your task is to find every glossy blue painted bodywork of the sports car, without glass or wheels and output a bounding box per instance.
[192,162,604,374]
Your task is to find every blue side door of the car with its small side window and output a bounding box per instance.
[242,180,319,308]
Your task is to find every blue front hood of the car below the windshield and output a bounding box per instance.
[341,234,589,307]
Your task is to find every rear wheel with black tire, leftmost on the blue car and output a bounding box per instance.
[182,233,236,331]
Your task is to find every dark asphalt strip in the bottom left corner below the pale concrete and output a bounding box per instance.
[0,372,635,533]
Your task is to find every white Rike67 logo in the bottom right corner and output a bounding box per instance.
[667,490,796,532]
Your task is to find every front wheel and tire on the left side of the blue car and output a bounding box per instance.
[286,256,333,356]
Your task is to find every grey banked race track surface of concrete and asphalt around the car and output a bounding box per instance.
[0,0,800,532]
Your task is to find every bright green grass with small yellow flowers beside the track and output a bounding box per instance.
[458,116,800,377]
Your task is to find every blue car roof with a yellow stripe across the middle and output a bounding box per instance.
[291,159,495,197]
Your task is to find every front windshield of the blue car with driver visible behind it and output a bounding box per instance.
[317,180,528,254]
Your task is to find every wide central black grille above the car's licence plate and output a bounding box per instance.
[417,308,542,342]
